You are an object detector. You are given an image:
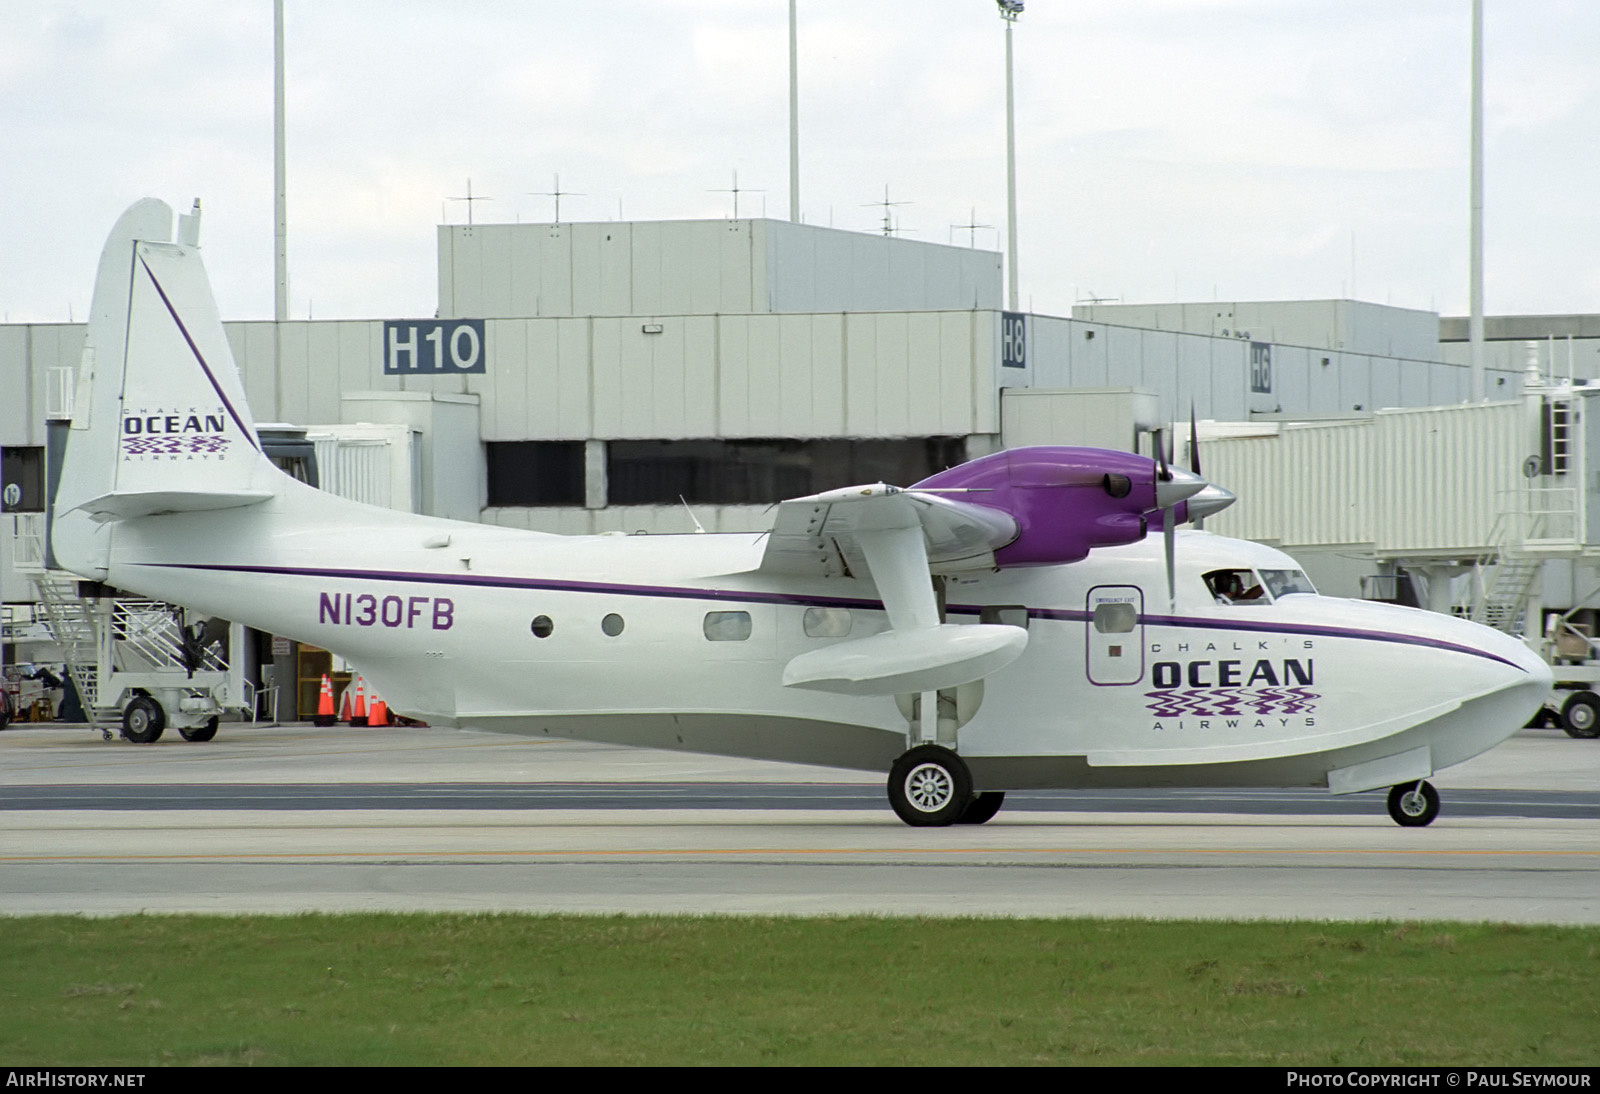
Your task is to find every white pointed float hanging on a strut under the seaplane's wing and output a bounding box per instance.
[784,624,1027,696]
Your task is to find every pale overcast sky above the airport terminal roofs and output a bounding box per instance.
[0,0,1600,323]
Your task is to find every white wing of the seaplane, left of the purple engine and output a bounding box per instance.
[760,483,1019,577]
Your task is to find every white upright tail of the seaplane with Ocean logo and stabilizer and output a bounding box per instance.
[56,198,277,521]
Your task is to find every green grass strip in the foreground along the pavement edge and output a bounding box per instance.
[0,915,1600,1067]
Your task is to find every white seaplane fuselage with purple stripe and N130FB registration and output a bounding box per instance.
[100,485,1547,789]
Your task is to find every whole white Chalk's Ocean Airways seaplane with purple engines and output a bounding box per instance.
[51,200,1550,825]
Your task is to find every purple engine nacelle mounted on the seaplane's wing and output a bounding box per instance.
[910,446,1177,566]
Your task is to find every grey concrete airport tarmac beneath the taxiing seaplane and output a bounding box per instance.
[0,725,1600,924]
